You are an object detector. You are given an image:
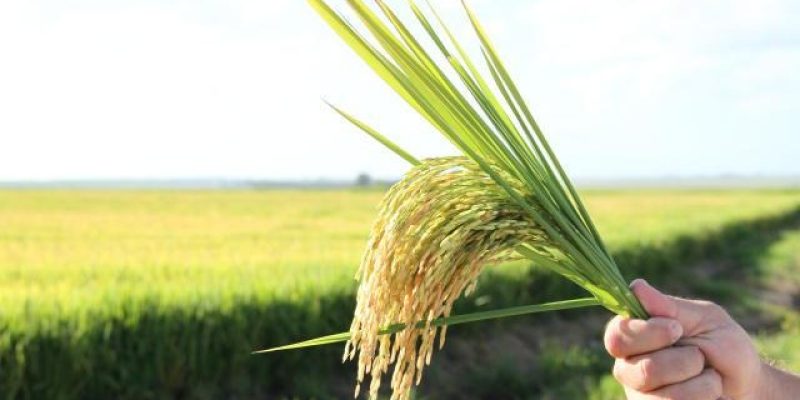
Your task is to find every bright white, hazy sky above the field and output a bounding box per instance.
[0,0,800,181]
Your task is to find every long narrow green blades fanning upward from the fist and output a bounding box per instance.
[309,0,646,330]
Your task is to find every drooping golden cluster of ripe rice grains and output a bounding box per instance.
[345,157,553,399]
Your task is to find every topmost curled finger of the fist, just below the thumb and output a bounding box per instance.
[603,317,683,358]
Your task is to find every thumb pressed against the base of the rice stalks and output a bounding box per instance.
[631,279,721,336]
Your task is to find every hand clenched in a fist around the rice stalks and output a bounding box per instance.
[605,280,772,400]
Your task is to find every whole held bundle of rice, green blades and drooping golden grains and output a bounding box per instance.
[260,0,646,399]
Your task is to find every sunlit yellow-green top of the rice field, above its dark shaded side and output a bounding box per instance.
[0,190,800,313]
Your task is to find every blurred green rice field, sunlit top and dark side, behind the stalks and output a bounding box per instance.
[0,190,800,398]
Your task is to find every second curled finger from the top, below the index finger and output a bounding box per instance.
[614,346,705,392]
